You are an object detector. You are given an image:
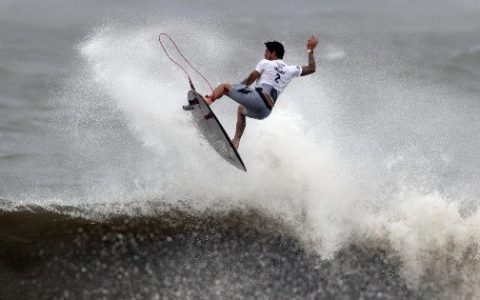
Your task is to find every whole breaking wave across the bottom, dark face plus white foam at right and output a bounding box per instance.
[0,196,479,299]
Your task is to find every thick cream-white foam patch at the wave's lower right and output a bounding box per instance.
[362,193,480,294]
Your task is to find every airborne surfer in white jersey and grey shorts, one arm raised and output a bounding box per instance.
[205,36,318,149]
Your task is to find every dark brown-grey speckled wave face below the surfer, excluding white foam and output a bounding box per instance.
[0,206,416,299]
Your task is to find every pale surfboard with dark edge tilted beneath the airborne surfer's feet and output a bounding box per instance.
[183,90,247,172]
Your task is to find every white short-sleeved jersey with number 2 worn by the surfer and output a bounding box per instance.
[255,59,302,94]
